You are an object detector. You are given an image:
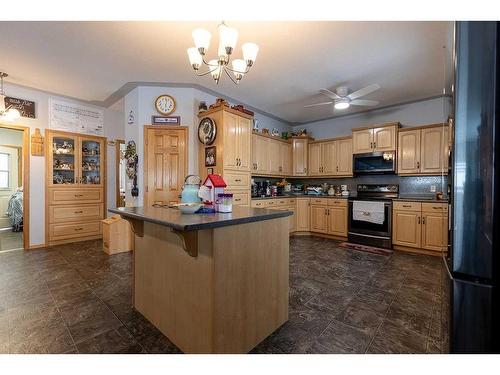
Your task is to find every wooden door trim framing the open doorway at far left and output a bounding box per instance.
[0,123,30,250]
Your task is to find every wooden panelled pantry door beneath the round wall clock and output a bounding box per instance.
[144,127,188,206]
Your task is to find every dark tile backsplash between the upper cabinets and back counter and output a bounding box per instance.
[254,175,448,197]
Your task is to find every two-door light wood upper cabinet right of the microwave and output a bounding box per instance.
[398,124,448,175]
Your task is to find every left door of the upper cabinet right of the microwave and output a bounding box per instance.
[398,129,420,174]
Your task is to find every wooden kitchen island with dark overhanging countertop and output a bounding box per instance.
[110,207,292,353]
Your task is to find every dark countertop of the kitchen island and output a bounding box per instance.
[109,206,292,231]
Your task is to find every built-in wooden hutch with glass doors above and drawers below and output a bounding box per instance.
[45,129,106,246]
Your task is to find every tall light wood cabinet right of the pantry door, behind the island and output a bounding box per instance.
[198,105,253,206]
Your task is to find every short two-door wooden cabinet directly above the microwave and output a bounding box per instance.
[352,123,399,154]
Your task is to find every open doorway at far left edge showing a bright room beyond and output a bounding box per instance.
[0,124,29,252]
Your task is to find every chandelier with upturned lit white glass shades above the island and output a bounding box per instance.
[187,22,259,85]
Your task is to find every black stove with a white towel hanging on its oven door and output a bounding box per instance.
[348,185,399,249]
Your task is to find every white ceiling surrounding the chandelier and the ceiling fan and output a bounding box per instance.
[0,22,453,123]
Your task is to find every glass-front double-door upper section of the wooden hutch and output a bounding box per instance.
[47,130,105,187]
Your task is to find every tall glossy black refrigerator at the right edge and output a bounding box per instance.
[442,22,500,353]
